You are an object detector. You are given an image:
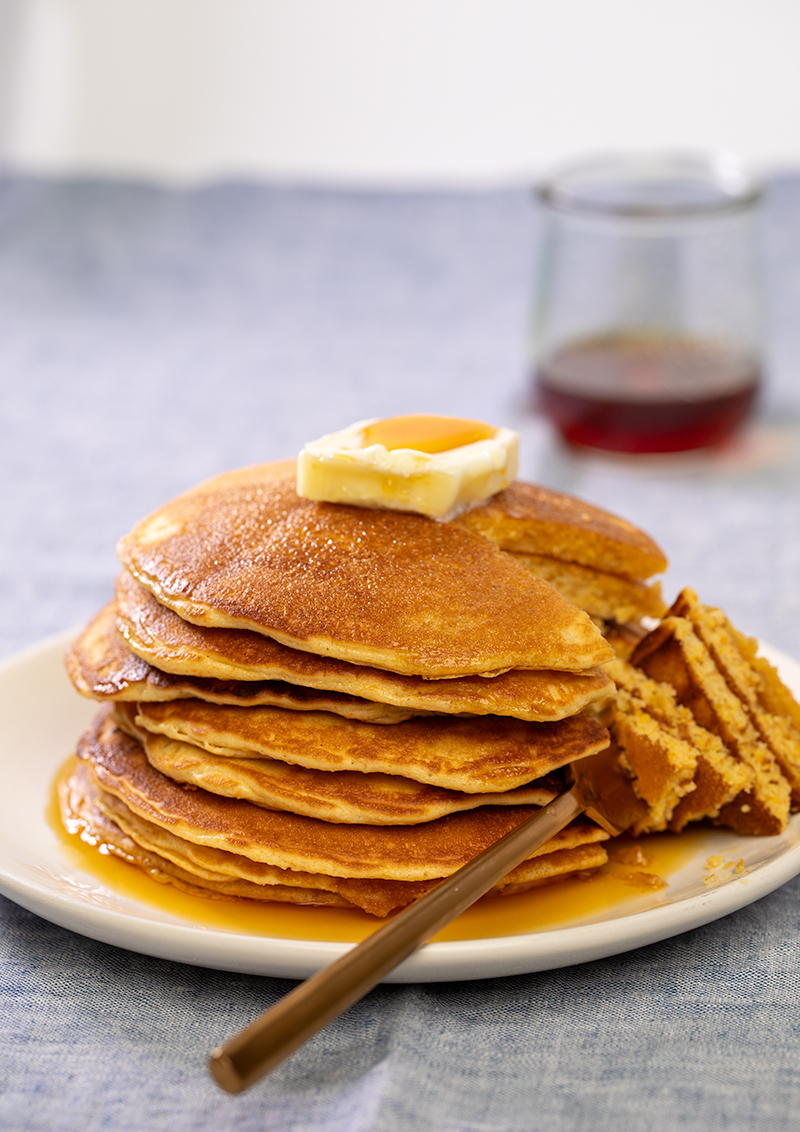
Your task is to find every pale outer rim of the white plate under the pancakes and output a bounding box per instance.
[0,629,800,983]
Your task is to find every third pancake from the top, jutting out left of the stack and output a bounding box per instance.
[64,606,418,723]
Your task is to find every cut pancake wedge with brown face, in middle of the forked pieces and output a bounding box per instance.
[631,617,791,835]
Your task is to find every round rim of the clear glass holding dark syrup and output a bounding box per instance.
[536,151,764,220]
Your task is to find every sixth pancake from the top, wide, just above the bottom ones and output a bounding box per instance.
[78,709,608,881]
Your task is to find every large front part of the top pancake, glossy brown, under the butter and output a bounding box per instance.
[118,463,611,678]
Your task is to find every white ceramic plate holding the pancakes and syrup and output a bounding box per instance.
[0,633,800,983]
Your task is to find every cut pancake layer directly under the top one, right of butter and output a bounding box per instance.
[509,551,666,624]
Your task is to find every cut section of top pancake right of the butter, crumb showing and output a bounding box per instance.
[454,480,666,578]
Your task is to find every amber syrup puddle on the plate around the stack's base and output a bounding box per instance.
[46,756,708,943]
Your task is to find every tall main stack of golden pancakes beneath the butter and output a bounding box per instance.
[61,464,664,915]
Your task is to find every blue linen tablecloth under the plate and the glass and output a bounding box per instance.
[0,178,800,1132]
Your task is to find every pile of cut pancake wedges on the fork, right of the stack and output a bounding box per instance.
[605,589,800,834]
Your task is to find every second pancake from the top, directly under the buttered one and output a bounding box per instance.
[112,572,613,721]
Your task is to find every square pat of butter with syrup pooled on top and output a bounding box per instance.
[298,414,519,520]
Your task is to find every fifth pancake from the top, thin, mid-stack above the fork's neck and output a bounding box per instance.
[123,709,565,825]
